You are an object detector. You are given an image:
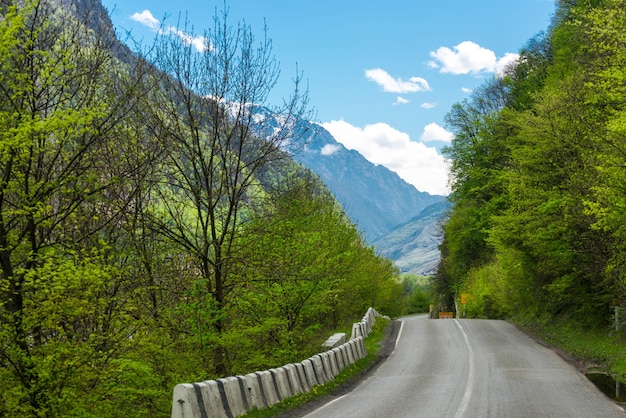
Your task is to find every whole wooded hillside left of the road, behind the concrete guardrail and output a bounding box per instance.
[0,0,402,417]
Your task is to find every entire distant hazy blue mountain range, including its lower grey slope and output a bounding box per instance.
[294,122,449,275]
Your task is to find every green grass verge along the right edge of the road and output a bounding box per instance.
[513,319,626,382]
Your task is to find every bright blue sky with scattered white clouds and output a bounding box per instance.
[102,0,554,194]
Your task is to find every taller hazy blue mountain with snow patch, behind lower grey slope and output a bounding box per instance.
[294,123,446,243]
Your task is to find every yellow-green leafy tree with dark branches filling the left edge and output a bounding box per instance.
[0,0,155,416]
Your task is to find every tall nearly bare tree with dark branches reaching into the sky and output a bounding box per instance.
[139,11,307,375]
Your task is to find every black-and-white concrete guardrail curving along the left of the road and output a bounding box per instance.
[172,308,388,418]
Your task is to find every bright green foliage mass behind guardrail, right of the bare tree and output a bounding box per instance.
[226,173,398,371]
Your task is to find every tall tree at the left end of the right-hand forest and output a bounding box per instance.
[435,77,511,309]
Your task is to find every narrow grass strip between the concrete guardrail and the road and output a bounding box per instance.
[244,318,390,418]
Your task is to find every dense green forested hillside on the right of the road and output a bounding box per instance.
[435,0,626,327]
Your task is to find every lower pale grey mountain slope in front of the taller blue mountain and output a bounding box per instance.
[372,200,450,275]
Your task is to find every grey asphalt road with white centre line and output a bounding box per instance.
[306,316,626,418]
